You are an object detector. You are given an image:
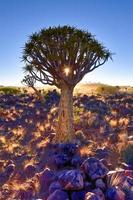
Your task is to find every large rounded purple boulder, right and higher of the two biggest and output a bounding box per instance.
[81,157,109,180]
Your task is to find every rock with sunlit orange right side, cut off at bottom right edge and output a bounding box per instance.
[106,186,126,200]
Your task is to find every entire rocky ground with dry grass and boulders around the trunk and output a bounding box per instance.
[0,90,133,200]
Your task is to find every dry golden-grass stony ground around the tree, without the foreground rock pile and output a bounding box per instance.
[0,89,133,199]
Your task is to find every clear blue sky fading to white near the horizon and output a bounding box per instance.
[0,0,133,86]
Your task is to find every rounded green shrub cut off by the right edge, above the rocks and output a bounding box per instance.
[122,144,133,165]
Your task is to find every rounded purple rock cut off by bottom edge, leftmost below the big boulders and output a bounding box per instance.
[47,190,69,200]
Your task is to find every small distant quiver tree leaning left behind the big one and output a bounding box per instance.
[21,75,44,102]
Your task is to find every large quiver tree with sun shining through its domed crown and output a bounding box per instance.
[23,26,111,142]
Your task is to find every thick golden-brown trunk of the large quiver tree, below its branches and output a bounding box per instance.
[56,85,74,142]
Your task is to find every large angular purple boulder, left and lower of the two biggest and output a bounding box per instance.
[58,170,84,190]
